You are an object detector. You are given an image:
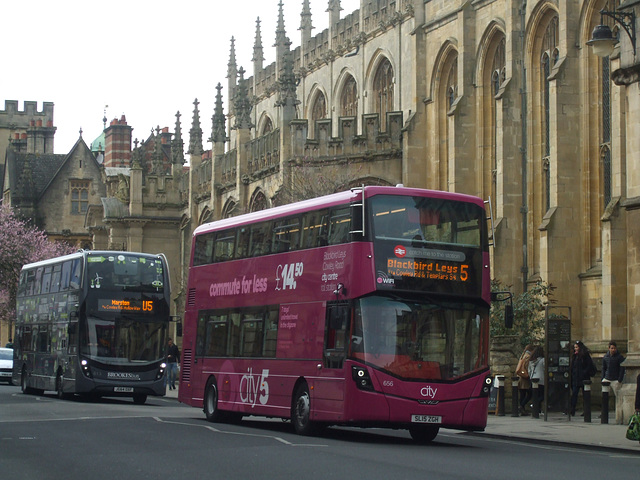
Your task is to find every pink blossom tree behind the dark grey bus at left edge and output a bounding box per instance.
[0,205,74,335]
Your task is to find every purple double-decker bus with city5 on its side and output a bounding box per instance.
[179,186,491,443]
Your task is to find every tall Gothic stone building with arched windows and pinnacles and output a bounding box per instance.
[1,0,640,416]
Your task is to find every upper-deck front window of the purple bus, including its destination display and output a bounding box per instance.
[369,195,487,296]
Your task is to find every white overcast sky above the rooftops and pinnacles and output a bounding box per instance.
[0,0,360,154]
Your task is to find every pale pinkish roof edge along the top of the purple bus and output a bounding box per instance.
[193,186,484,237]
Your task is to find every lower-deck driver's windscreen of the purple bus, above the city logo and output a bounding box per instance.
[351,296,488,380]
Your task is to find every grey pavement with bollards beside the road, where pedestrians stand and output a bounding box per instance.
[166,388,640,455]
